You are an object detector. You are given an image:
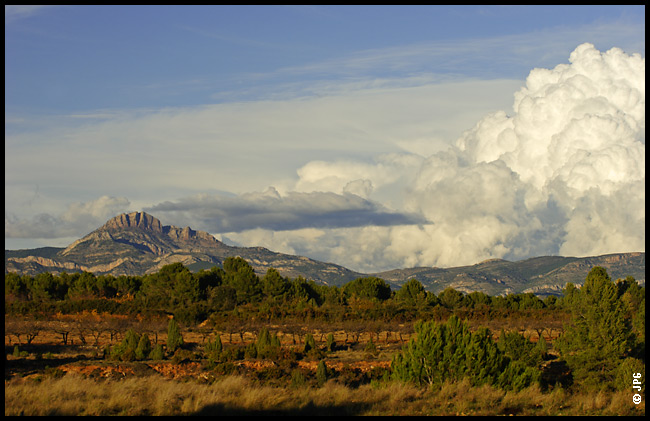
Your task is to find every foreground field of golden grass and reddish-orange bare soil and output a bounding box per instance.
[5,316,645,416]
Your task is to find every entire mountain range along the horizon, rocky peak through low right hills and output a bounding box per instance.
[5,212,645,296]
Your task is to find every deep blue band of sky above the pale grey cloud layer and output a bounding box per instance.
[5,6,645,113]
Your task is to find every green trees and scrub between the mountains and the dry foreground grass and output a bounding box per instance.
[5,258,645,402]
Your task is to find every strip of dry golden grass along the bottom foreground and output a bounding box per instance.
[5,374,645,415]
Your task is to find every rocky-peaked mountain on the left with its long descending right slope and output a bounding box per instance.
[5,212,361,284]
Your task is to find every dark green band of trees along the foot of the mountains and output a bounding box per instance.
[5,257,645,324]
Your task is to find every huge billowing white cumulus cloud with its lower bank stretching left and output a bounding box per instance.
[260,44,645,270]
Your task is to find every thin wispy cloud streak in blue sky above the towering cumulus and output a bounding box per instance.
[251,22,645,84]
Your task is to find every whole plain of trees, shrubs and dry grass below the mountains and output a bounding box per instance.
[5,259,645,415]
